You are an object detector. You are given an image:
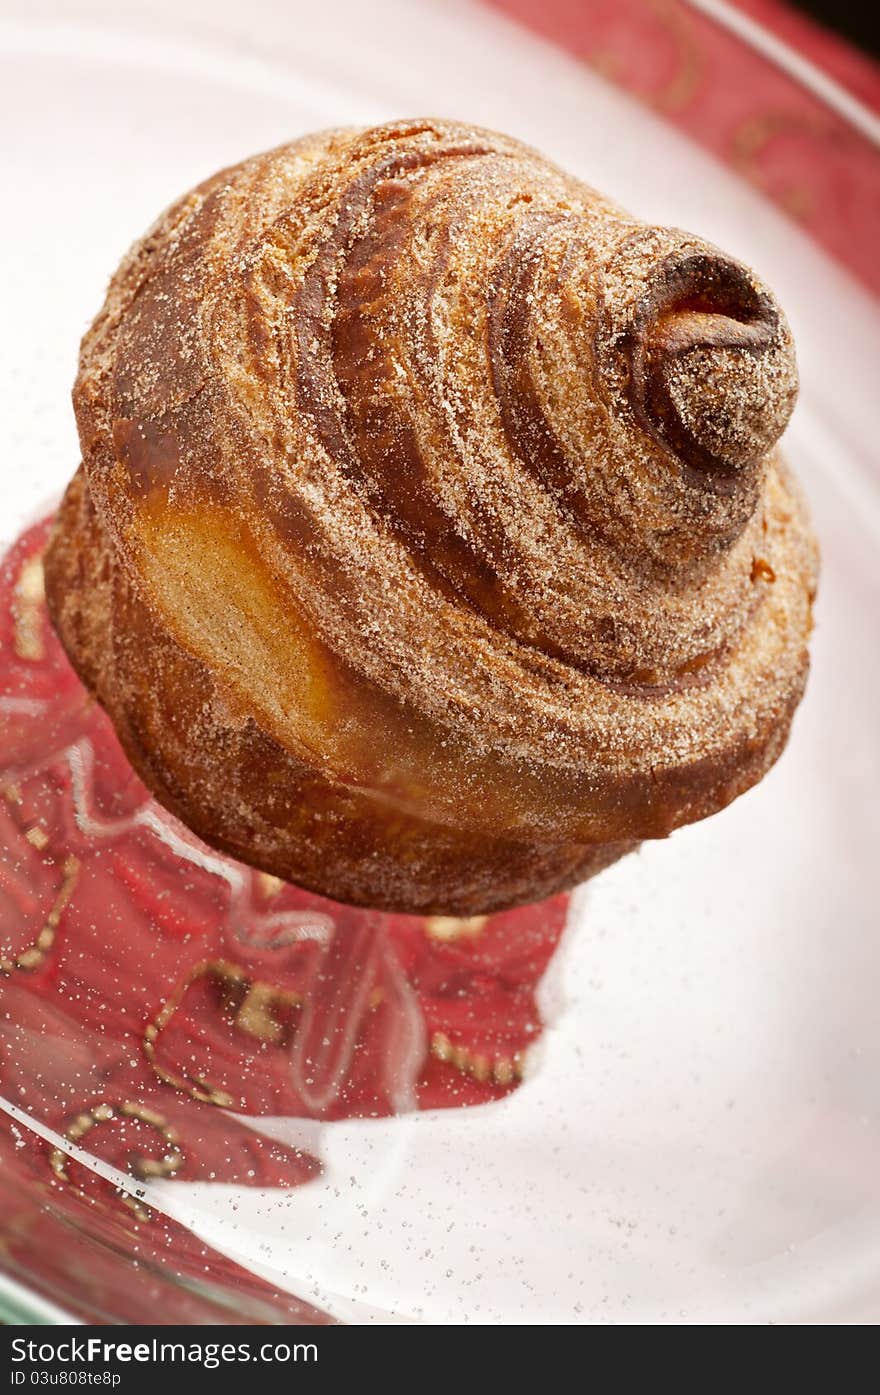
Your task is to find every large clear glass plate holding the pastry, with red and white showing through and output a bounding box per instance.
[0,0,880,1324]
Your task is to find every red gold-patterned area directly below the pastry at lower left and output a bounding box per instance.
[0,523,566,1322]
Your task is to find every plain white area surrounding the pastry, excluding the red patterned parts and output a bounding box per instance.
[0,0,880,1322]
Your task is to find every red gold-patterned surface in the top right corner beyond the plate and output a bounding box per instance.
[484,0,880,294]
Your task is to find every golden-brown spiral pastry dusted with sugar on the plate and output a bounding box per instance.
[46,120,816,915]
